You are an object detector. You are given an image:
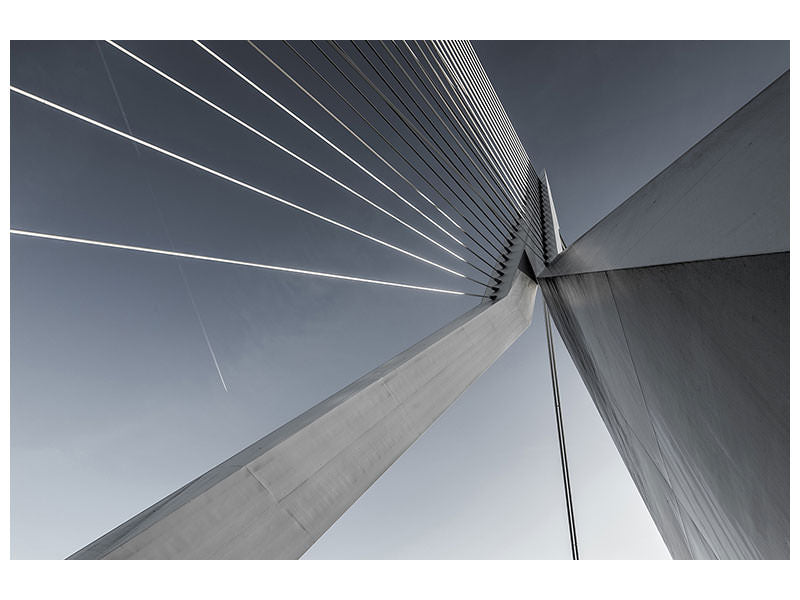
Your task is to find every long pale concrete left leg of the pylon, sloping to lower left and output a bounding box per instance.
[70,271,537,559]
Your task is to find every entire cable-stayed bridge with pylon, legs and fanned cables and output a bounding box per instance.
[11,41,788,558]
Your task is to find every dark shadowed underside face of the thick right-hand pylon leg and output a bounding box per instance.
[540,252,789,558]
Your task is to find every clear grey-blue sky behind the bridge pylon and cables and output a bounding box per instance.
[11,42,789,558]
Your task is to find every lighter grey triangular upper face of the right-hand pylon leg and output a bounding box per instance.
[537,72,789,276]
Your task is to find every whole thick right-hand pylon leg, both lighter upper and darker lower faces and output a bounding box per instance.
[538,72,789,558]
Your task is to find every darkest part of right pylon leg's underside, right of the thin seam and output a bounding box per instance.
[608,253,789,557]
